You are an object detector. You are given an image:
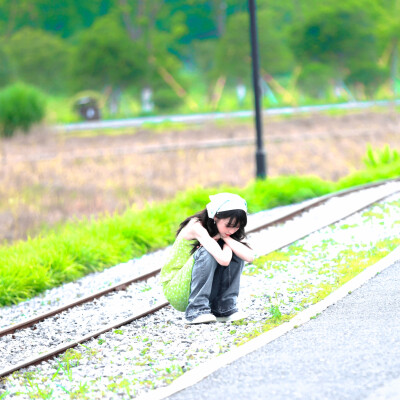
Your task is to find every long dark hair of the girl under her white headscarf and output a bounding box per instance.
[176,208,247,254]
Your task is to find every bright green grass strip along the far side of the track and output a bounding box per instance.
[0,157,400,306]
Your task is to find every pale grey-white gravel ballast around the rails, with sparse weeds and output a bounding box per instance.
[0,183,400,399]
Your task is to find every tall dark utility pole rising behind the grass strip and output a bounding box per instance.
[248,0,267,179]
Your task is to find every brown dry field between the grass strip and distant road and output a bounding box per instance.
[0,110,400,240]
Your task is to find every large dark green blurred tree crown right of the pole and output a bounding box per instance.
[291,0,378,78]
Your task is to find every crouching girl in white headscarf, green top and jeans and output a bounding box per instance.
[161,193,254,324]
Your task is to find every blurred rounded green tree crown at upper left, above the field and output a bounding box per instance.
[71,12,181,94]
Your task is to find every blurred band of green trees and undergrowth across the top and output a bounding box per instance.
[0,0,400,122]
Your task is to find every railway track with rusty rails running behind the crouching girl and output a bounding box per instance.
[0,180,400,378]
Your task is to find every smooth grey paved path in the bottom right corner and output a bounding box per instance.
[169,261,400,400]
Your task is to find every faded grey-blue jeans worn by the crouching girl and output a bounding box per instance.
[185,247,244,321]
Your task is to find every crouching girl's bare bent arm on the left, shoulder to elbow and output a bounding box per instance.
[180,220,232,266]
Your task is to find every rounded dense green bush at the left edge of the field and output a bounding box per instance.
[0,83,45,137]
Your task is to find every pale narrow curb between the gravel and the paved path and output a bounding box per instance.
[137,246,400,400]
